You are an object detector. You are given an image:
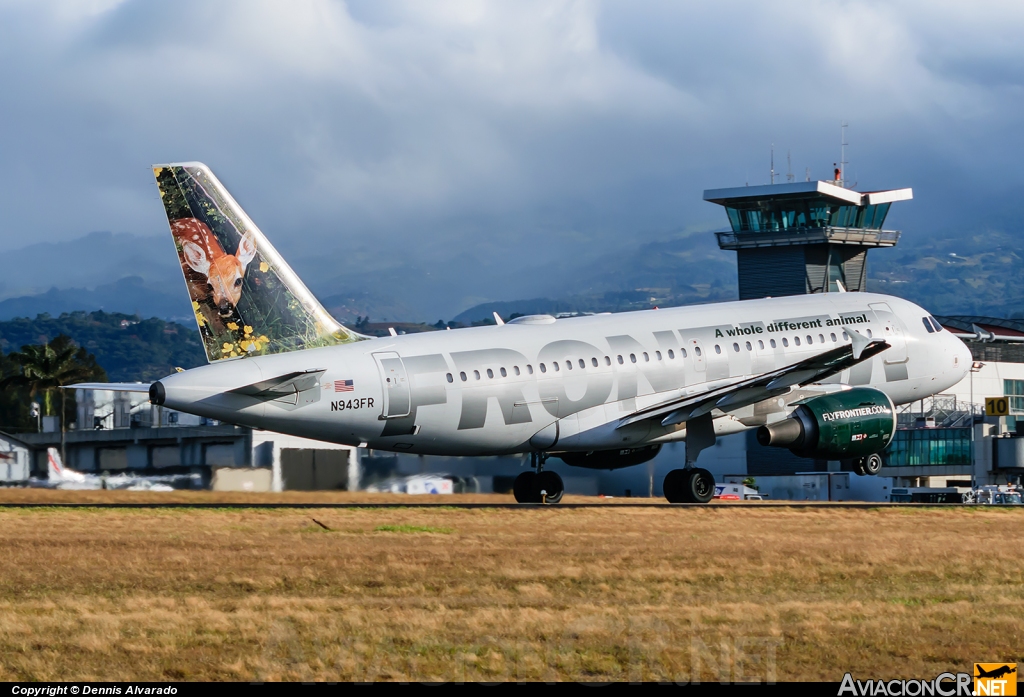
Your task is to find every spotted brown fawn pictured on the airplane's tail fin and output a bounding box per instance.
[171,218,256,317]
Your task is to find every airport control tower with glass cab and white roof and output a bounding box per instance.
[703,181,913,300]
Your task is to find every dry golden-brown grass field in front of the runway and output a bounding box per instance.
[0,492,1024,682]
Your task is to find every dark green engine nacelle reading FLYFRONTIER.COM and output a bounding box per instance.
[757,387,896,460]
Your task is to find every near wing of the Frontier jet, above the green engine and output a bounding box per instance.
[615,332,889,428]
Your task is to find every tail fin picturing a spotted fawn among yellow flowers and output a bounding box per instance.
[153,163,367,362]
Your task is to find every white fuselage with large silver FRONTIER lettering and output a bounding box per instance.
[155,293,971,455]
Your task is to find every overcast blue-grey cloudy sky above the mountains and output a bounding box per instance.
[0,0,1024,290]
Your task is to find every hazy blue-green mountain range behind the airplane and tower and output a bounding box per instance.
[0,216,1024,324]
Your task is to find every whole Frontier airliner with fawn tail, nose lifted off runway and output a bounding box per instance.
[72,163,972,504]
